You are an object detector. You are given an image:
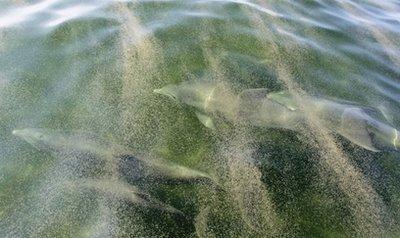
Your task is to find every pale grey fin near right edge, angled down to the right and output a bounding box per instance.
[340,107,379,152]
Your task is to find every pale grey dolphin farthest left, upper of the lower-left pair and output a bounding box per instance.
[12,128,212,182]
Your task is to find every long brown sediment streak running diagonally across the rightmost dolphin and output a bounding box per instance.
[249,2,386,236]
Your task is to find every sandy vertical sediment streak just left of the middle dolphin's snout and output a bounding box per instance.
[118,4,162,151]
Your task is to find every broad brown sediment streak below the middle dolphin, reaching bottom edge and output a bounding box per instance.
[195,20,280,237]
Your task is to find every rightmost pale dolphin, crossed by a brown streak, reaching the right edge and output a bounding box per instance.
[268,91,400,152]
